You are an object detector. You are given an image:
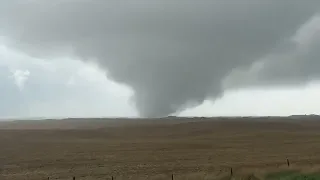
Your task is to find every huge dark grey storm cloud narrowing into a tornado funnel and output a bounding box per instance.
[0,0,320,116]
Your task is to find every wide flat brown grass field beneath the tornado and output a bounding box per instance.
[0,117,320,180]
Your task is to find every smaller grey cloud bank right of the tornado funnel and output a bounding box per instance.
[224,20,320,88]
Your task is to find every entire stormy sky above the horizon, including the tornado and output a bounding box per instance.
[0,0,320,118]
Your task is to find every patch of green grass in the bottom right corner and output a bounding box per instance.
[265,171,320,180]
